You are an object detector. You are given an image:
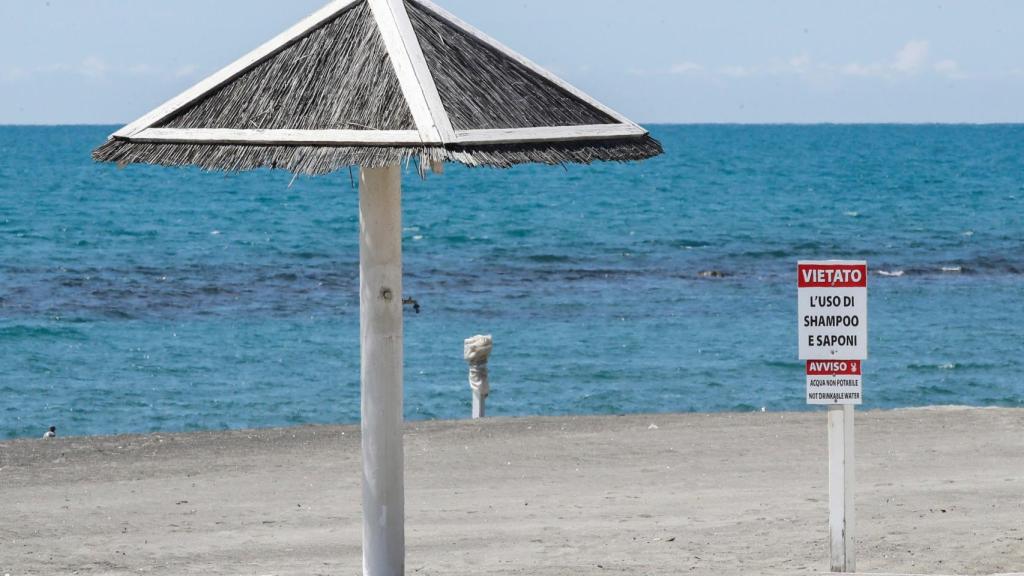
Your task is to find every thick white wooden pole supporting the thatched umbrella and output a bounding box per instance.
[359,166,406,576]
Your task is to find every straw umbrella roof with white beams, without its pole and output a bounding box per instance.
[93,0,662,174]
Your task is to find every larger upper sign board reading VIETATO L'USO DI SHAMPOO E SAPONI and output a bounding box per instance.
[797,260,867,360]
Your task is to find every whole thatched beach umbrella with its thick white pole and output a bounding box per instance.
[93,0,662,576]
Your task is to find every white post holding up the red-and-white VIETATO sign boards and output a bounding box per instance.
[828,405,857,572]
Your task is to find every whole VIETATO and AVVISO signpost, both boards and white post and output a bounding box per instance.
[797,260,867,572]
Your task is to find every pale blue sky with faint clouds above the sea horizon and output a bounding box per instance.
[0,0,1024,124]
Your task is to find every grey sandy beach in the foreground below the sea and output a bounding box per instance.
[0,408,1024,576]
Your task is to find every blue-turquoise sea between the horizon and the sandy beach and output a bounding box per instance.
[0,125,1024,439]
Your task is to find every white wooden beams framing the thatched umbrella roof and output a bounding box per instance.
[112,0,647,147]
